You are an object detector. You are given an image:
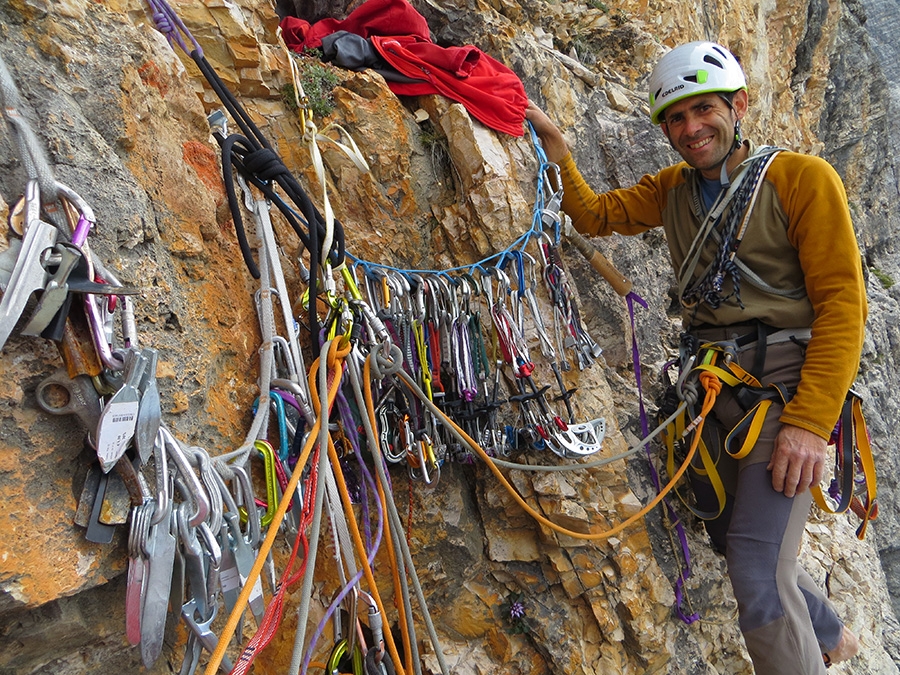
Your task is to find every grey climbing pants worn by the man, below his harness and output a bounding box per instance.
[692,328,843,675]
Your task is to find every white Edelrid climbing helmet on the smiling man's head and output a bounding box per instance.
[650,42,747,124]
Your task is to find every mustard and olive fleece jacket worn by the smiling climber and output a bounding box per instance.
[560,146,868,439]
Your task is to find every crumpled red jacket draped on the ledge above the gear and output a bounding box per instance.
[281,0,528,136]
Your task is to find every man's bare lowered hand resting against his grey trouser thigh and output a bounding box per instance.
[767,424,828,497]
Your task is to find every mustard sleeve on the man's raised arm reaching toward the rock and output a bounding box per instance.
[559,153,670,237]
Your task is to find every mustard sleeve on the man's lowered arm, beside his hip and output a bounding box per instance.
[776,153,868,439]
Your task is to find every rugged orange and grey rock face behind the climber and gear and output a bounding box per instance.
[0,0,900,675]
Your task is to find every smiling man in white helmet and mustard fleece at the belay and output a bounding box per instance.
[526,42,867,675]
